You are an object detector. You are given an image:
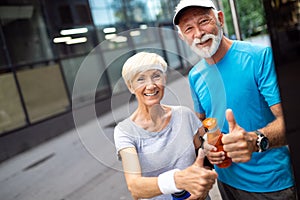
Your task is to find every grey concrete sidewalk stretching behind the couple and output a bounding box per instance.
[0,76,221,200]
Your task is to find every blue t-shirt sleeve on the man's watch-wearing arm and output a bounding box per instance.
[258,47,281,106]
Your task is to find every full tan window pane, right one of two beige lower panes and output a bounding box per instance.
[17,65,70,122]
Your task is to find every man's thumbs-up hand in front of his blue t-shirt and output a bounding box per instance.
[222,109,257,162]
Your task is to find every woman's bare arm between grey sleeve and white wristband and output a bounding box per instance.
[120,148,162,199]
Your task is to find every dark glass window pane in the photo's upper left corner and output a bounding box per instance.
[0,0,53,64]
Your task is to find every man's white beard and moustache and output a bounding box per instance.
[190,27,223,58]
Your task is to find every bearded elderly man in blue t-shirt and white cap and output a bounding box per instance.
[173,0,296,200]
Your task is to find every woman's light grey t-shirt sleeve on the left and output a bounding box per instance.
[114,125,135,160]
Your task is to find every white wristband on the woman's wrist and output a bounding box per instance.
[158,169,182,194]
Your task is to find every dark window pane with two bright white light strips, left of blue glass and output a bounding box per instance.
[45,0,98,58]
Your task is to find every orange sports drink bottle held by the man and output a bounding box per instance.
[202,118,232,168]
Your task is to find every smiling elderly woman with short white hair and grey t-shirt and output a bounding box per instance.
[114,52,217,200]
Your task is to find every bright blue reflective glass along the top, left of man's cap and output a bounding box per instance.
[89,0,177,27]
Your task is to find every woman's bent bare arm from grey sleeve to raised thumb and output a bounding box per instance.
[120,144,217,200]
